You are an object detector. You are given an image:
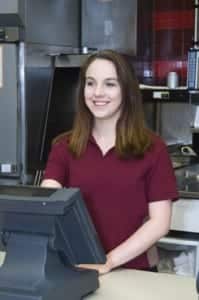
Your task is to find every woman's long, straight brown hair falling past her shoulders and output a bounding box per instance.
[69,50,152,158]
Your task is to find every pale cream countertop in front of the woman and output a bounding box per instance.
[84,269,198,300]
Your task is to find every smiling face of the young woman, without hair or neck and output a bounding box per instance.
[84,59,122,120]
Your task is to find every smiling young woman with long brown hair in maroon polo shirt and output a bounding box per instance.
[42,50,178,274]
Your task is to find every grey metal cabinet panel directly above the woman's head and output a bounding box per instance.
[81,0,138,55]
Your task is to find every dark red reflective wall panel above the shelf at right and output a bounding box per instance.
[136,0,194,85]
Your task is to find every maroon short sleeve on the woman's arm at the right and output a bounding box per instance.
[146,142,179,202]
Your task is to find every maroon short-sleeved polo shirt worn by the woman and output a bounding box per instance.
[44,135,178,269]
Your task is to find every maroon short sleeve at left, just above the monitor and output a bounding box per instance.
[43,143,69,186]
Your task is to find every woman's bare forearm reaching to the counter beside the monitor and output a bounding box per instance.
[80,200,171,274]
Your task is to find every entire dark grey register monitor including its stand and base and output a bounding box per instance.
[0,186,106,300]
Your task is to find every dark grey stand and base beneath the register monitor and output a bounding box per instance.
[0,233,99,300]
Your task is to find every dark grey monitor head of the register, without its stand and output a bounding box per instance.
[0,186,106,264]
